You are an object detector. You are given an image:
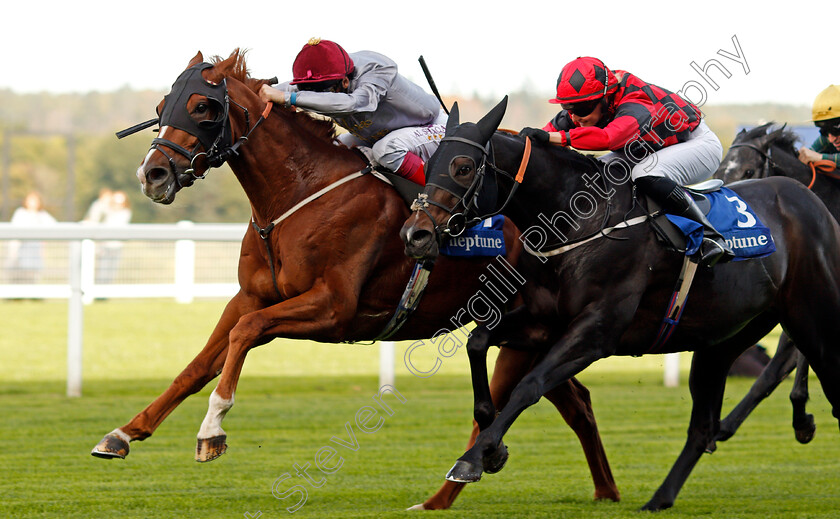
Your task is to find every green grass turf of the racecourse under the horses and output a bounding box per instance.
[0,302,840,518]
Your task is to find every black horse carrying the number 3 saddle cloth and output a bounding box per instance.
[401,99,840,510]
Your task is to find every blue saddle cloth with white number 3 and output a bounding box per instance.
[667,187,776,261]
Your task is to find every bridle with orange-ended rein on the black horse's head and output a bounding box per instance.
[411,132,531,244]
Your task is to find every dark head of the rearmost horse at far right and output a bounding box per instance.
[714,122,796,184]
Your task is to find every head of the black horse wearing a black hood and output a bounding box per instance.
[400,97,507,259]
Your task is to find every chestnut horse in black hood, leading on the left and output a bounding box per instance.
[92,50,619,508]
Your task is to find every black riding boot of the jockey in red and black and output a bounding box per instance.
[636,177,735,267]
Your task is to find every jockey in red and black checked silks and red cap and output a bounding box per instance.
[520,57,733,267]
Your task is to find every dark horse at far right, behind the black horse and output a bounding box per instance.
[714,122,840,443]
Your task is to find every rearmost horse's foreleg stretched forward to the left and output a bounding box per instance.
[715,333,804,441]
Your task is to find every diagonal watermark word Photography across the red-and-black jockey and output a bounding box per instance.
[519,35,750,263]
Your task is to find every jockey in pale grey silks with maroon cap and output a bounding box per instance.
[260,38,447,186]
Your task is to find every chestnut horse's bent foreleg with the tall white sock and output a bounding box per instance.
[195,284,346,462]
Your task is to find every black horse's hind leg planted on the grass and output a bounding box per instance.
[642,342,740,511]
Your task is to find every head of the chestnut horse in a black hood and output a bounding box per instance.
[134,49,267,204]
